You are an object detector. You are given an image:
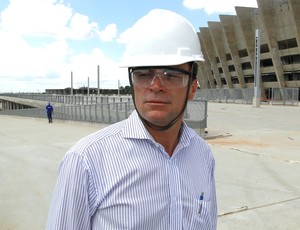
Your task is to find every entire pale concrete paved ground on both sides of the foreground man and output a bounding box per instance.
[0,103,300,230]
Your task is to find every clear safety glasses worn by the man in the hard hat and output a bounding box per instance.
[128,66,193,89]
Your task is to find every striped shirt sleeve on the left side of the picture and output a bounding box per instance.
[46,153,91,230]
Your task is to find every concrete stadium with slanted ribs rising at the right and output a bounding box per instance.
[198,0,300,97]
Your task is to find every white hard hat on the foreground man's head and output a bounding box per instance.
[121,9,204,67]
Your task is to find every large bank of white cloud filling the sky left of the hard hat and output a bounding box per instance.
[0,0,128,92]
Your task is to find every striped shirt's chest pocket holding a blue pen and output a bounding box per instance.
[189,199,212,230]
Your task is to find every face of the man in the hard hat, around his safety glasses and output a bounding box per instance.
[134,63,197,126]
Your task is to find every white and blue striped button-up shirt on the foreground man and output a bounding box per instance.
[47,112,217,230]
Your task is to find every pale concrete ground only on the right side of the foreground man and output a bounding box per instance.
[207,104,300,230]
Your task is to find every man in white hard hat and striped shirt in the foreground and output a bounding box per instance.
[47,10,217,230]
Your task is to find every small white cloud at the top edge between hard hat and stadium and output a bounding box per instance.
[183,0,257,14]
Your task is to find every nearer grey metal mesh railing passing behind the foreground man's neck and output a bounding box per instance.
[0,95,207,135]
